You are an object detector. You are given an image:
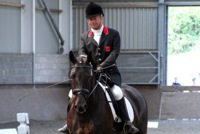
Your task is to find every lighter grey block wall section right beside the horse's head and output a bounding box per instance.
[34,54,69,83]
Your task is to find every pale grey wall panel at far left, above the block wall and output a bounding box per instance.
[0,0,21,53]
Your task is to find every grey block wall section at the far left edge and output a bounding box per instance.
[0,54,33,84]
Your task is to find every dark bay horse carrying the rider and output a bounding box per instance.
[67,51,148,134]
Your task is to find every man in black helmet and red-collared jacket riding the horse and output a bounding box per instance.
[58,2,139,133]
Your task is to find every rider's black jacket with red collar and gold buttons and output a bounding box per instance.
[78,26,121,86]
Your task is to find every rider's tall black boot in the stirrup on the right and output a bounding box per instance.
[117,97,139,134]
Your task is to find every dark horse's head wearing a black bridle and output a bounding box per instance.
[69,51,95,113]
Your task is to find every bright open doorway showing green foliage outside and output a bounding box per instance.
[167,6,200,86]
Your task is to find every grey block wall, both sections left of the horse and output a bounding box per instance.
[0,53,69,84]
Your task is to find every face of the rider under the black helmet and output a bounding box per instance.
[87,15,103,30]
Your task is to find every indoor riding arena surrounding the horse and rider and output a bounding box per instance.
[0,0,200,134]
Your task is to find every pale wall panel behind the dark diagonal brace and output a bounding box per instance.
[35,0,59,54]
